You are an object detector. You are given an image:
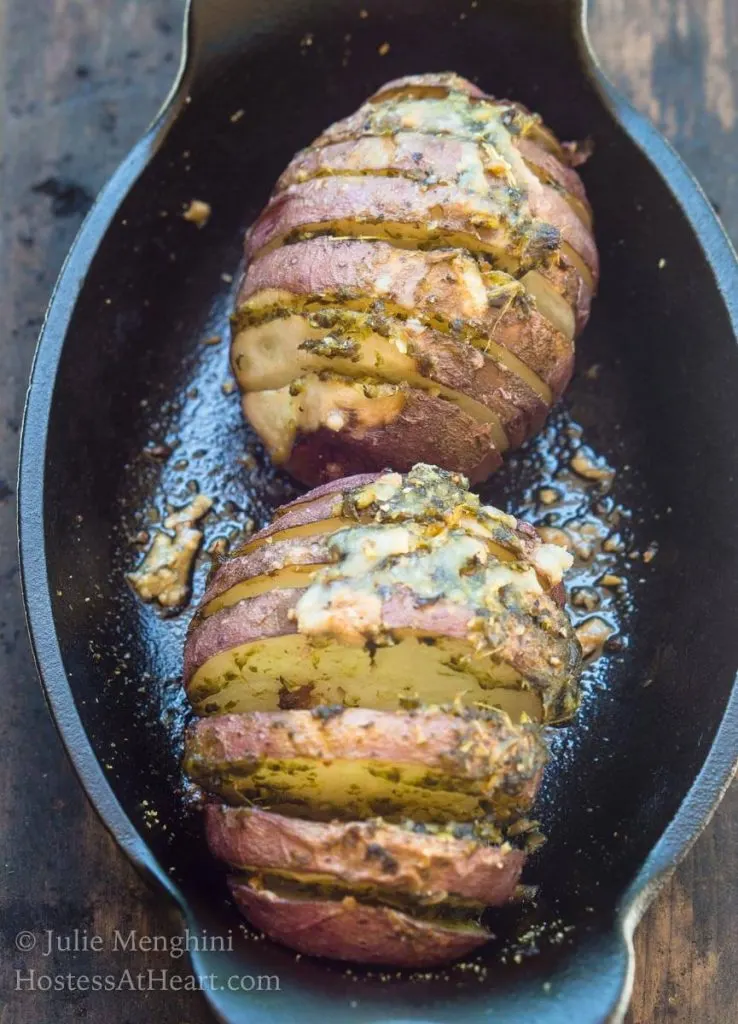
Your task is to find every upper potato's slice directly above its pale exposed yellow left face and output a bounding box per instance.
[236,238,573,403]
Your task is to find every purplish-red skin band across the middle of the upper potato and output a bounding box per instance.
[238,238,574,395]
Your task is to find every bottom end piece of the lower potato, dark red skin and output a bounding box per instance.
[230,881,491,968]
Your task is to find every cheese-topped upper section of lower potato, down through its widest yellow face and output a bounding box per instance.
[190,466,580,721]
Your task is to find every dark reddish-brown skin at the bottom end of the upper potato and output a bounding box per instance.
[284,388,503,484]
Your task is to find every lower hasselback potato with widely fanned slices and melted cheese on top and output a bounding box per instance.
[184,465,580,967]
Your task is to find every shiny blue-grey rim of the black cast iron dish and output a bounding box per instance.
[17,0,738,1022]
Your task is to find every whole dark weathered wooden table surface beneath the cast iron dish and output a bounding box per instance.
[0,0,738,1024]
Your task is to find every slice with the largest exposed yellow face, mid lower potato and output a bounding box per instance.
[185,590,579,721]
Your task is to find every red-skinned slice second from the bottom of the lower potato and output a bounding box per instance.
[205,804,525,906]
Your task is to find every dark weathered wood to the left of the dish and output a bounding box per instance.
[0,8,211,1024]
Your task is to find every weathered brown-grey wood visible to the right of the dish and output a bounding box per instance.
[591,8,738,1024]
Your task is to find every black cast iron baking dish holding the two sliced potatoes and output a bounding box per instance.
[19,0,738,1024]
